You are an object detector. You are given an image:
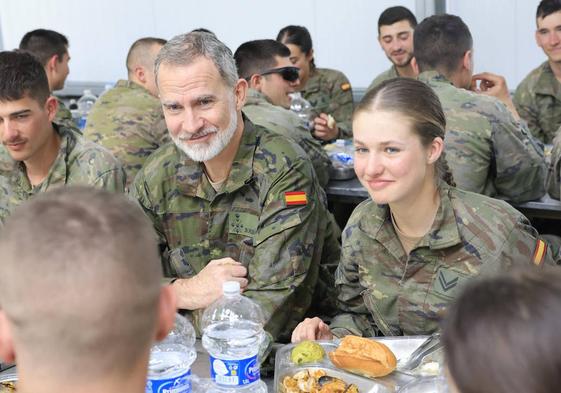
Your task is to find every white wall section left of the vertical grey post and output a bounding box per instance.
[0,0,416,87]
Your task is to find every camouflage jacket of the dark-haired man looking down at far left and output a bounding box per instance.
[0,125,125,221]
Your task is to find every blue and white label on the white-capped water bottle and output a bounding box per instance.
[210,355,261,386]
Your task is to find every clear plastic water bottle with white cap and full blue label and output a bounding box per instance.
[202,281,267,393]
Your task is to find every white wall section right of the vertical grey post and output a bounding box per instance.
[446,0,546,90]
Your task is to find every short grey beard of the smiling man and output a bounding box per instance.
[170,97,238,162]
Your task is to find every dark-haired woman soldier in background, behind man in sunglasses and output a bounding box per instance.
[277,26,353,141]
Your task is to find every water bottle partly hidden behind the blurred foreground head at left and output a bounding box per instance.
[146,314,197,393]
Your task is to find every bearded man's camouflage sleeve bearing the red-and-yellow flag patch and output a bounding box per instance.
[240,160,325,340]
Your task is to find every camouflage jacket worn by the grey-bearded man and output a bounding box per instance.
[131,119,340,339]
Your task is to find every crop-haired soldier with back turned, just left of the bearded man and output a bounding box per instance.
[84,37,170,186]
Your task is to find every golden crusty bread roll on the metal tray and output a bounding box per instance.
[329,336,397,377]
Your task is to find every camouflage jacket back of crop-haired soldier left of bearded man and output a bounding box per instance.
[84,80,170,186]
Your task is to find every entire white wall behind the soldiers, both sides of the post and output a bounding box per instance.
[0,0,545,89]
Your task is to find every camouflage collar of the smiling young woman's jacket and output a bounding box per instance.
[359,182,462,251]
